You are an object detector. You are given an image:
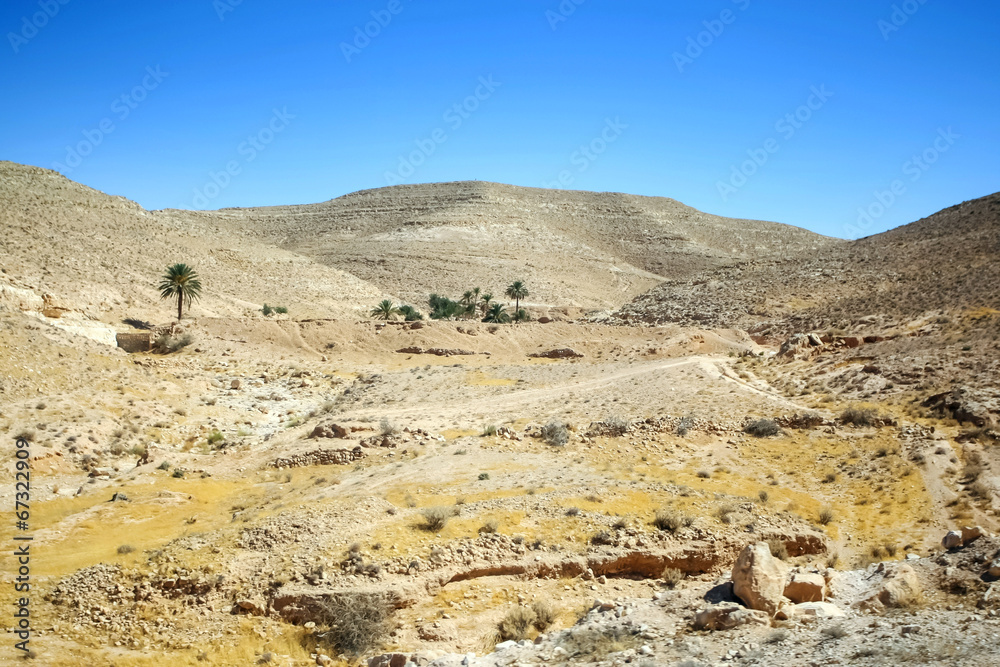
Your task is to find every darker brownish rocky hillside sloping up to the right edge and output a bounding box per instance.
[619,193,1000,333]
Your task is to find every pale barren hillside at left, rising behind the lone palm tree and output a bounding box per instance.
[0,162,382,322]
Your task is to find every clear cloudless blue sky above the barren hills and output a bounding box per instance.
[0,0,1000,237]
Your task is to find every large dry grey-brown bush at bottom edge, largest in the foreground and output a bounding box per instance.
[316,593,392,656]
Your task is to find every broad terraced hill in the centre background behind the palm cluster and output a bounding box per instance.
[218,182,842,308]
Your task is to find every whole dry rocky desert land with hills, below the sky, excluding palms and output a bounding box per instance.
[0,162,1000,667]
